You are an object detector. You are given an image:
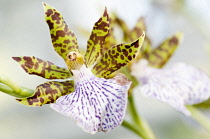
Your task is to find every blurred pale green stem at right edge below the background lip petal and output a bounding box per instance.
[187,106,210,134]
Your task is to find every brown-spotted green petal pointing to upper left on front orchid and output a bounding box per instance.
[43,3,78,59]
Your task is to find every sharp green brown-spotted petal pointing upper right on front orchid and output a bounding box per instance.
[92,33,145,78]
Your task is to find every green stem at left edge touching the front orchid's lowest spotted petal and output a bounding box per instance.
[0,75,34,98]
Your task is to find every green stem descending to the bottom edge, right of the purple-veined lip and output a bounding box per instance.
[128,95,155,139]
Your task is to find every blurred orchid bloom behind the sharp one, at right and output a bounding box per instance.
[109,16,210,116]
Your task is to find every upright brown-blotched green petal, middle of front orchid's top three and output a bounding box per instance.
[85,9,109,67]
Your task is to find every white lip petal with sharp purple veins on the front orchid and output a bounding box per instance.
[51,66,131,134]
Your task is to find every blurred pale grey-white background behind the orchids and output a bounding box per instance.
[0,0,210,139]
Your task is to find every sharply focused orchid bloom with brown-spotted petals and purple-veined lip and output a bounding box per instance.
[13,3,144,134]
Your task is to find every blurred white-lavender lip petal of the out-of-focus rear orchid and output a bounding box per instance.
[132,60,210,116]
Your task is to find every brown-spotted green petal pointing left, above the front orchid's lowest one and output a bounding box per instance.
[13,56,72,79]
